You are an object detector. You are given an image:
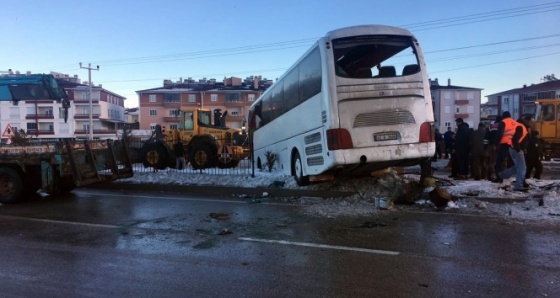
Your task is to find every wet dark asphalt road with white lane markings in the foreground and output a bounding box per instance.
[0,189,560,297]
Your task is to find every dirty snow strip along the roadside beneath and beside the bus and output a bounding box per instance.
[117,160,560,222]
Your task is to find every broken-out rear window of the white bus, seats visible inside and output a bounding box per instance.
[332,35,420,78]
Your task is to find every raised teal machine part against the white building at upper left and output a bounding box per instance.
[0,74,70,122]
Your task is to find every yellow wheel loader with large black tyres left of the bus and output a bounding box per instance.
[142,108,249,170]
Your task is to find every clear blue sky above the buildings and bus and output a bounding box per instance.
[0,0,560,107]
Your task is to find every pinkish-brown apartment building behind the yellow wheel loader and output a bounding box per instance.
[136,76,272,129]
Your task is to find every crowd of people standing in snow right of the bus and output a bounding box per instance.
[434,111,543,191]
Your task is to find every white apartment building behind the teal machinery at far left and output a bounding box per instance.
[0,72,125,141]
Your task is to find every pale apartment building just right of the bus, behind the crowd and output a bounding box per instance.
[430,79,482,132]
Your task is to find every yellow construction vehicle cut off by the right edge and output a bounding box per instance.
[531,98,560,160]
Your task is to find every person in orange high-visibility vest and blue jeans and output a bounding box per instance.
[497,117,528,191]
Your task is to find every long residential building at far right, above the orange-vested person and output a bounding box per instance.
[486,76,560,120]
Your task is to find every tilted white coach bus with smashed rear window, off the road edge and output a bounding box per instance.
[248,25,435,185]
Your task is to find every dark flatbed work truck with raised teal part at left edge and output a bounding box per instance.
[0,74,133,203]
